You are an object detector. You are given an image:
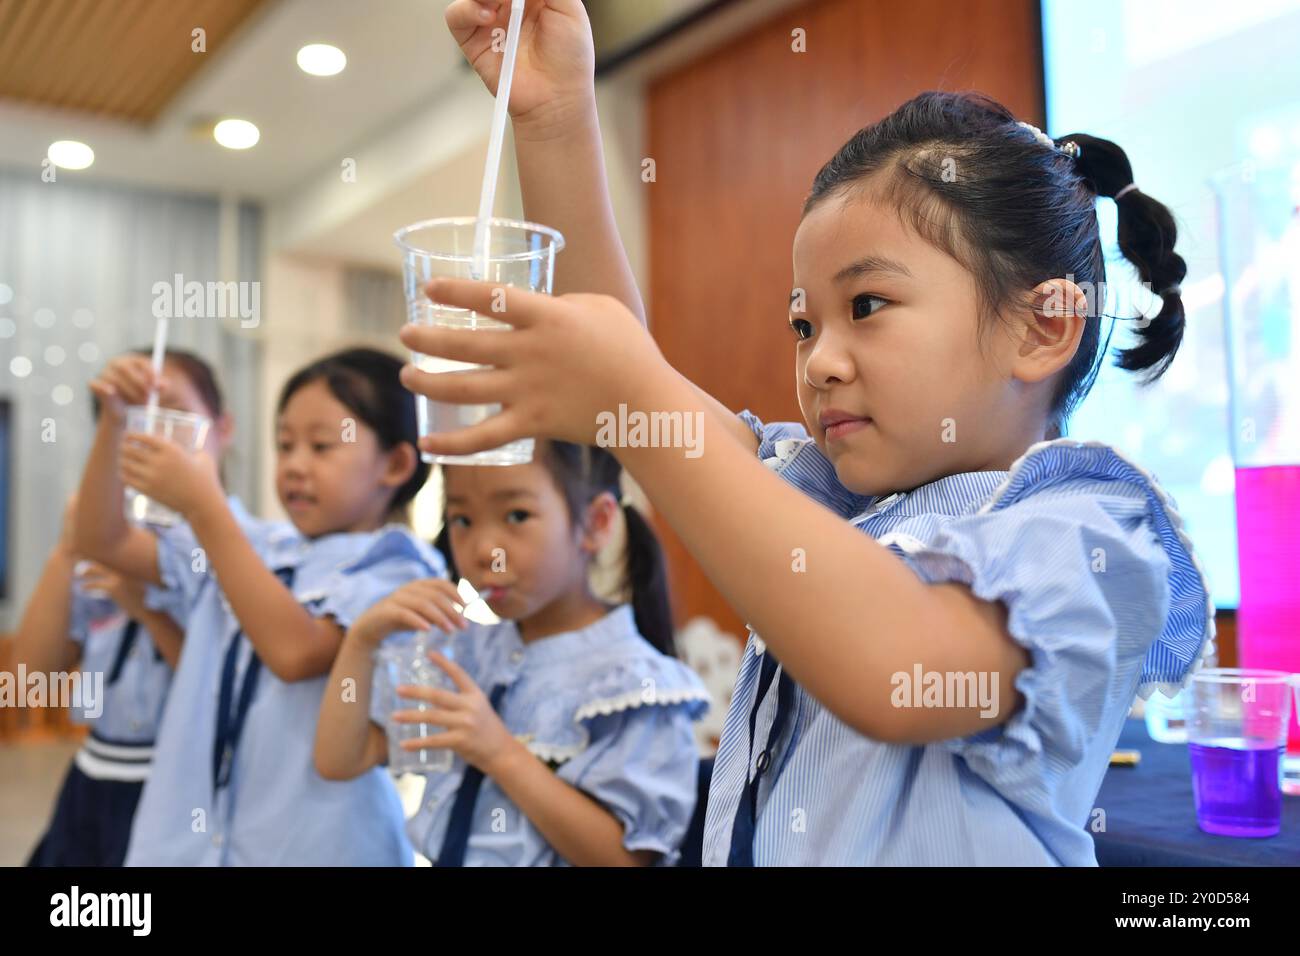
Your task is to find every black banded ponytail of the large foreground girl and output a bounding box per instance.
[1057,133,1187,382]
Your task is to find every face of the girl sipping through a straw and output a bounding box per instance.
[442,460,603,620]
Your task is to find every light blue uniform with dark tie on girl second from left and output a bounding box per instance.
[126,509,446,866]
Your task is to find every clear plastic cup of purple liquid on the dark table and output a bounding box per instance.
[1184,667,1292,836]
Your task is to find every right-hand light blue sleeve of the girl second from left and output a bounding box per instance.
[300,527,447,628]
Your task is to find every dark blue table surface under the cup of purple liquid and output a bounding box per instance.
[1089,721,1300,866]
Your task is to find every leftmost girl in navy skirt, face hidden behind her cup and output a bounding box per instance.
[14,349,231,866]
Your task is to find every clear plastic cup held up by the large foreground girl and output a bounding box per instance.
[393,216,564,464]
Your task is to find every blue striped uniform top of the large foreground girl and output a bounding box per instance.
[703,411,1214,866]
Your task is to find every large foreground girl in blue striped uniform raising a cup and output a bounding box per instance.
[402,0,1213,865]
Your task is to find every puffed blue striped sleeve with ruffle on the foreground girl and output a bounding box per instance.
[880,440,1213,806]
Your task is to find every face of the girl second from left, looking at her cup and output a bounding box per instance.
[276,381,416,537]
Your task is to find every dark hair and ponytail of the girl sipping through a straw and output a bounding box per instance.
[538,441,676,656]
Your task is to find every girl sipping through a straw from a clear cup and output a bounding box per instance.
[316,442,709,866]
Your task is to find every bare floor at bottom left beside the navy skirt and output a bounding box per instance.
[0,739,81,866]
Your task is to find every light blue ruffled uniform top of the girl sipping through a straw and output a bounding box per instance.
[371,604,709,866]
